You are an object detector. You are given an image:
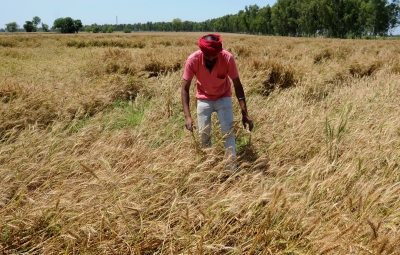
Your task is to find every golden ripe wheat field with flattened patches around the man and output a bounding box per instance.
[0,33,400,254]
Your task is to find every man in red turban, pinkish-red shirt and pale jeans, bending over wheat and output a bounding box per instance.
[181,34,253,171]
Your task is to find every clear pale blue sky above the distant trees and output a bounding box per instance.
[0,0,276,28]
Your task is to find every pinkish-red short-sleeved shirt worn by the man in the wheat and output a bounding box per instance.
[183,50,239,100]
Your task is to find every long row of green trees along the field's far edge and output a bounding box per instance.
[3,0,400,38]
